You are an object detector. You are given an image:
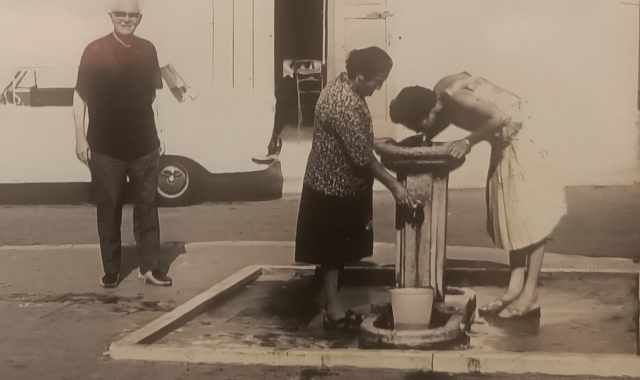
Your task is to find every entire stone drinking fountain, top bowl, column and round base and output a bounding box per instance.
[360,135,476,349]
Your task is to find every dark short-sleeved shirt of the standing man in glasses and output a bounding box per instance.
[76,34,162,161]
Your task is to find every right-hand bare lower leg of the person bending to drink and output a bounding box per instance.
[499,241,546,318]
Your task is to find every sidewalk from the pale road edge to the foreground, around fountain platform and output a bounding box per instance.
[0,241,640,380]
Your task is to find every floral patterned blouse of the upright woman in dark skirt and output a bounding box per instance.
[304,73,373,196]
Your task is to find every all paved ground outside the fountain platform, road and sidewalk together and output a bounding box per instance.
[0,186,640,380]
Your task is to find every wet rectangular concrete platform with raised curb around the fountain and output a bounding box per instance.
[109,266,640,376]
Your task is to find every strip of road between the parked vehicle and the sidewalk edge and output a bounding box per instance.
[0,185,640,257]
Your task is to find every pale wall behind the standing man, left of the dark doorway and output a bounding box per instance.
[0,0,274,90]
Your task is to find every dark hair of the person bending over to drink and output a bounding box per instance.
[389,86,437,128]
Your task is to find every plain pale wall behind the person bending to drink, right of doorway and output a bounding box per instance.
[391,0,640,187]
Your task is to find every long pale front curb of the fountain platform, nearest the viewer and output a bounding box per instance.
[109,342,640,378]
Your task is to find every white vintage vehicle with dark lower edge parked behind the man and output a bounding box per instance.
[0,65,283,206]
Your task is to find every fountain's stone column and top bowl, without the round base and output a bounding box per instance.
[376,137,464,302]
